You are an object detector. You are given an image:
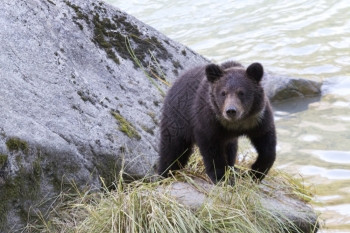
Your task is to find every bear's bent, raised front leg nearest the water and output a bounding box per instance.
[249,129,276,181]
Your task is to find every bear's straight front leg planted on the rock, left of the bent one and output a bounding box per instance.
[196,138,227,183]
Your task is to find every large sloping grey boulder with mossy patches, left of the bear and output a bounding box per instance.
[0,0,322,232]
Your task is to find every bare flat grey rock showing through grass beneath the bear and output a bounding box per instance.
[158,178,319,233]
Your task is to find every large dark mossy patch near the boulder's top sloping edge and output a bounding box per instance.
[65,0,173,76]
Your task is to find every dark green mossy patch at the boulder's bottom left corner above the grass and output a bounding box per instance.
[0,148,86,229]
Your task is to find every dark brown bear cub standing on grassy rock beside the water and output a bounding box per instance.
[158,62,276,183]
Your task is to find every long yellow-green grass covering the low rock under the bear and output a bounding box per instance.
[23,148,310,233]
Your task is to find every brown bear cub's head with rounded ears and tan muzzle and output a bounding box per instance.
[205,63,266,127]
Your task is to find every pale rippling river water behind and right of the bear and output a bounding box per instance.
[107,0,350,233]
